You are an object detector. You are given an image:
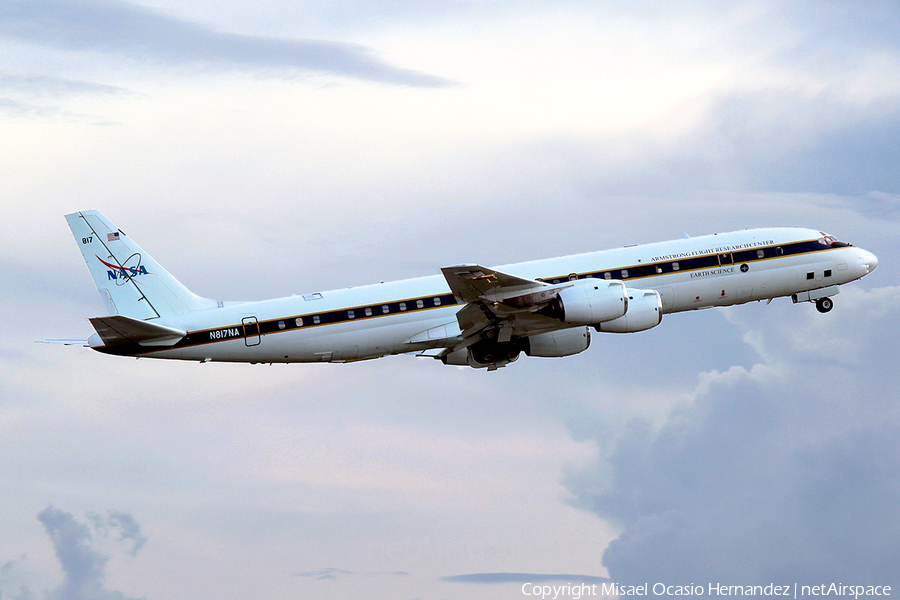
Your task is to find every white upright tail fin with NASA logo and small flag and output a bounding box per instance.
[66,210,216,320]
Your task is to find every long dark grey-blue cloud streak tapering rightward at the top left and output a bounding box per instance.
[0,0,449,87]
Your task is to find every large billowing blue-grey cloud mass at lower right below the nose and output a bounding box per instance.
[568,288,900,586]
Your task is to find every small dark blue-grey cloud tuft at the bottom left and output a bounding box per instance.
[38,506,146,600]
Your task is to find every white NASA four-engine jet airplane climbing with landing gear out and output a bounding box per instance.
[44,210,878,371]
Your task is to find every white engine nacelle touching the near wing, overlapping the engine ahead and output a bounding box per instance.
[540,279,628,325]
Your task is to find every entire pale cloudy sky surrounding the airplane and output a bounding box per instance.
[0,0,900,600]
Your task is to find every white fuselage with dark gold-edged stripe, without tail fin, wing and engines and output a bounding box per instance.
[90,228,877,363]
